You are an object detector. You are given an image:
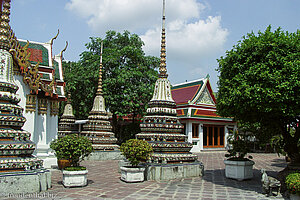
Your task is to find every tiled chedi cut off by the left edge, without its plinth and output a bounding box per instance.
[0,0,43,172]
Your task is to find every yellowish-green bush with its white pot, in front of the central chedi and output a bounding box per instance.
[120,139,153,183]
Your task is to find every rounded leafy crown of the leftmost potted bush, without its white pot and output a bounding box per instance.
[50,134,93,167]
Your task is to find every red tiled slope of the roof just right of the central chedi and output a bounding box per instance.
[172,84,201,104]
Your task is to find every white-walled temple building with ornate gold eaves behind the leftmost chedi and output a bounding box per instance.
[14,33,67,168]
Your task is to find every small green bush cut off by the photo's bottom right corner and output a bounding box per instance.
[285,172,300,200]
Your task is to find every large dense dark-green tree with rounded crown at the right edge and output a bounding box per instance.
[217,26,300,164]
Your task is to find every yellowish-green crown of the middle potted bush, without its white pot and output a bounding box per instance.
[120,139,153,167]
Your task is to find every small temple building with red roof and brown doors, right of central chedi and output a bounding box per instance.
[172,76,236,152]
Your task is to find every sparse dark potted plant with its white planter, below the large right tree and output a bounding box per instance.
[224,132,255,180]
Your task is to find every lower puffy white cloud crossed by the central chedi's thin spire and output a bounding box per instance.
[141,16,228,60]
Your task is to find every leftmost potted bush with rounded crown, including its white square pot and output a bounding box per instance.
[50,134,93,187]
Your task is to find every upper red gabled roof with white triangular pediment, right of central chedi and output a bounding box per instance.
[172,77,216,105]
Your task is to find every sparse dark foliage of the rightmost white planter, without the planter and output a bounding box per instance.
[225,131,253,161]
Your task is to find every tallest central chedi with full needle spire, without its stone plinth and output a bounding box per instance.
[136,0,197,164]
